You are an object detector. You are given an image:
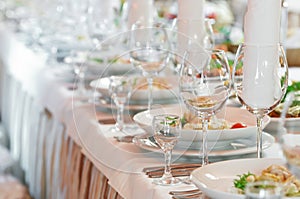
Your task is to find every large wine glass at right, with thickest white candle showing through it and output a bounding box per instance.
[232,44,288,158]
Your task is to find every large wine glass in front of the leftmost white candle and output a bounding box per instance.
[129,22,170,116]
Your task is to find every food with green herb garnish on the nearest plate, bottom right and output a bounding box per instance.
[233,165,300,197]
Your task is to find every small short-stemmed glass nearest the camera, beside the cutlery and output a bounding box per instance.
[152,114,181,185]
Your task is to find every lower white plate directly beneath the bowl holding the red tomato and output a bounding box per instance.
[133,132,275,158]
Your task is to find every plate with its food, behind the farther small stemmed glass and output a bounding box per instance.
[90,76,179,104]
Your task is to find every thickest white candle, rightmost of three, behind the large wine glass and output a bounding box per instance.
[242,0,281,108]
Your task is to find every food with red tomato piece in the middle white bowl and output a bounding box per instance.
[181,111,247,130]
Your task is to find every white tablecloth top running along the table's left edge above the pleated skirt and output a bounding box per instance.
[0,24,288,199]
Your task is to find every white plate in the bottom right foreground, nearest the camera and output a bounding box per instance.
[191,158,299,199]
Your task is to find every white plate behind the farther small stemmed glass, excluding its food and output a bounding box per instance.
[90,76,178,104]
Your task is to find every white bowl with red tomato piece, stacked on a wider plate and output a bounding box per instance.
[133,105,270,143]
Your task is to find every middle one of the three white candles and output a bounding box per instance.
[177,0,206,57]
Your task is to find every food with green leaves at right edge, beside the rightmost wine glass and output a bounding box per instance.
[269,81,300,118]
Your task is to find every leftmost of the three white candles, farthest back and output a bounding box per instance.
[127,0,155,29]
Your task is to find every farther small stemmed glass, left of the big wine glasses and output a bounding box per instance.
[109,76,133,132]
